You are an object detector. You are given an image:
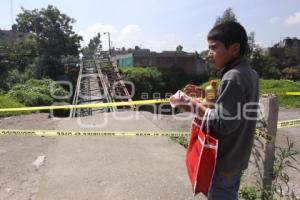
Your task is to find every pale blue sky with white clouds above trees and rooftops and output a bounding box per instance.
[0,0,300,51]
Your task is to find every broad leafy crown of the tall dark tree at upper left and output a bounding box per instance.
[16,5,82,58]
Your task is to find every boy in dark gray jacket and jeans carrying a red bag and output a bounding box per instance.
[187,22,259,200]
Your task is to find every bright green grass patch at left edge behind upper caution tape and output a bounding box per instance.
[0,96,30,117]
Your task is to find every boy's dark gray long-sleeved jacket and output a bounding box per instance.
[209,58,259,171]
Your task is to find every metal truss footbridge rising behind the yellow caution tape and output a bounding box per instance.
[71,54,135,117]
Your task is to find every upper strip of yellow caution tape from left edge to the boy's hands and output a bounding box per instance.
[0,99,169,112]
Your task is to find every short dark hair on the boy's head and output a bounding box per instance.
[207,21,248,56]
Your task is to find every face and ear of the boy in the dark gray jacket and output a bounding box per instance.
[208,39,240,70]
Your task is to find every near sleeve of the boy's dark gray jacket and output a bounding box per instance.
[208,80,245,138]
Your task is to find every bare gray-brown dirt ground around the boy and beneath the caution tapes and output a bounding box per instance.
[0,109,300,200]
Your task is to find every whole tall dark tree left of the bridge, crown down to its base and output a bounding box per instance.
[15,5,82,79]
